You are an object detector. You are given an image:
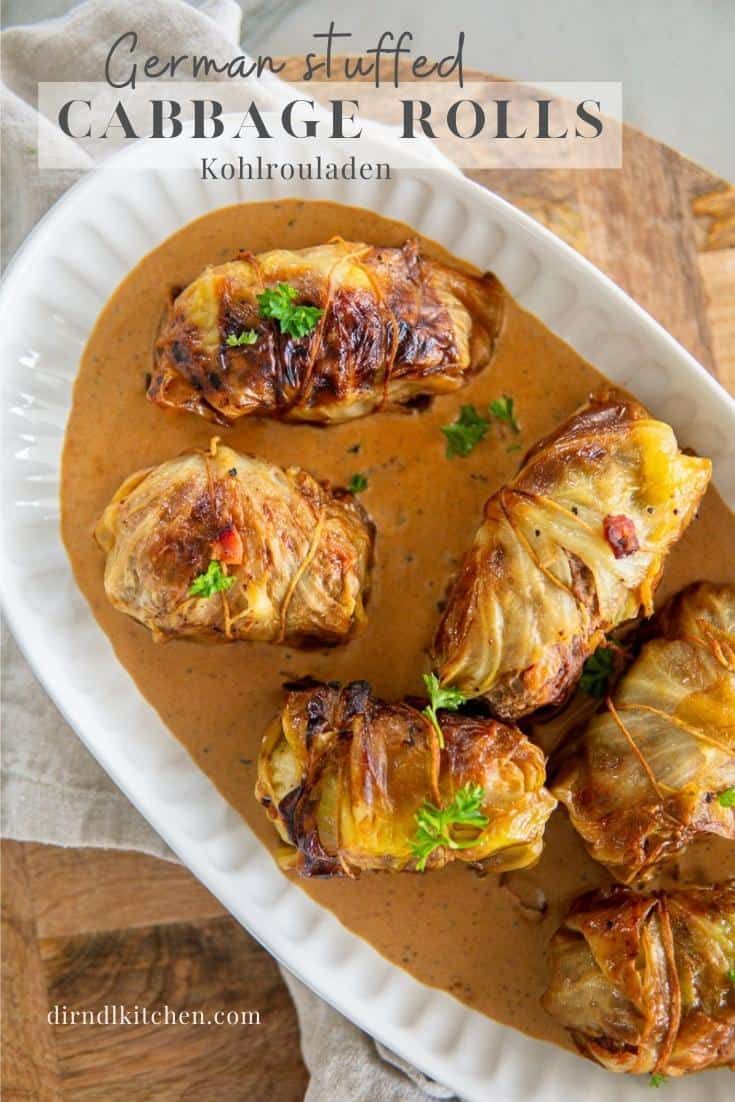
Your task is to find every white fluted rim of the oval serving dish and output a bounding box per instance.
[0,131,735,1102]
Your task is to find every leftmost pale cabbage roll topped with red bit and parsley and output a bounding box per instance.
[95,440,374,645]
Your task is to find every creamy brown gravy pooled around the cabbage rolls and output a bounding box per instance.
[62,201,735,1047]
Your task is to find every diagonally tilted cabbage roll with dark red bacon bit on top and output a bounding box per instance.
[433,392,711,719]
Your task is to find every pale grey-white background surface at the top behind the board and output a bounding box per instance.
[2,0,735,181]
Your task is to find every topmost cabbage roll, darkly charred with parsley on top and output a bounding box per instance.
[148,239,504,424]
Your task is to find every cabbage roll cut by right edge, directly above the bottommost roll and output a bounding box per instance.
[553,583,735,883]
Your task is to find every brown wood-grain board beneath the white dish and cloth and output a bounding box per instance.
[2,64,735,1102]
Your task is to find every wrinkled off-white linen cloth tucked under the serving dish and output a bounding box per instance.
[0,0,460,1102]
